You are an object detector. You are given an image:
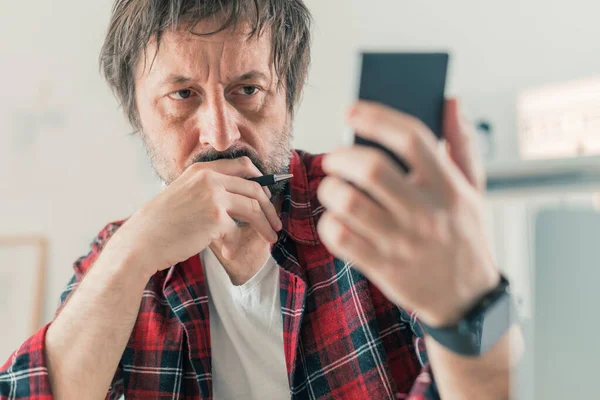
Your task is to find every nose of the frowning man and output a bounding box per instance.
[198,92,240,151]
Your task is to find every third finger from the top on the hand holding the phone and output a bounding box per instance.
[317,176,397,237]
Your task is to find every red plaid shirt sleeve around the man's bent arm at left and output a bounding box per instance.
[0,223,123,400]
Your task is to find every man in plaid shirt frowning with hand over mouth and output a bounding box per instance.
[0,0,511,399]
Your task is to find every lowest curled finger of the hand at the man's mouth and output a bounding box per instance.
[222,192,277,244]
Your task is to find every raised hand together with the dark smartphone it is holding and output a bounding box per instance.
[317,50,499,340]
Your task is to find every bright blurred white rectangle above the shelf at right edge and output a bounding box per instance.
[517,77,600,160]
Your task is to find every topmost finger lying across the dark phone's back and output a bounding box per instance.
[348,101,445,185]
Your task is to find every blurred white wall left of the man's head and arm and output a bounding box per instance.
[0,0,159,319]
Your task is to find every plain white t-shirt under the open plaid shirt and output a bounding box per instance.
[201,248,290,400]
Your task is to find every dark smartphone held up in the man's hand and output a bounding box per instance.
[353,52,449,172]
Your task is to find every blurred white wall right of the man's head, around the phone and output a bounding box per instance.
[297,0,600,161]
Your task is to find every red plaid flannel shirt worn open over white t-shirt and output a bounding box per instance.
[0,152,439,400]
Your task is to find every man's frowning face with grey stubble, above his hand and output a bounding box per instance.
[135,19,291,194]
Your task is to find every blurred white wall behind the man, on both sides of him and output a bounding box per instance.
[0,0,600,319]
